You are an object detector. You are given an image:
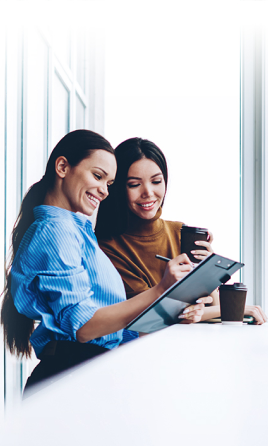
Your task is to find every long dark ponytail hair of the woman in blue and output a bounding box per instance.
[1,130,114,357]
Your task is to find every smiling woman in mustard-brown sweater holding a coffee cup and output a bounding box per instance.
[95,138,266,323]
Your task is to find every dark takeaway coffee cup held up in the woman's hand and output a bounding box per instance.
[181,225,208,263]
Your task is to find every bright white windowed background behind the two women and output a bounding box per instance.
[0,0,268,413]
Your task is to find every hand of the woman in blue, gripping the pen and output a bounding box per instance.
[159,254,193,291]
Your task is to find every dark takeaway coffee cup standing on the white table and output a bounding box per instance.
[219,283,247,325]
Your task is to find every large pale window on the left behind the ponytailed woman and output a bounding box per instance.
[0,11,103,413]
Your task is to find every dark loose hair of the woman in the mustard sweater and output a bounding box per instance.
[95,138,168,240]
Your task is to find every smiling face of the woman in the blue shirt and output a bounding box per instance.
[61,150,116,216]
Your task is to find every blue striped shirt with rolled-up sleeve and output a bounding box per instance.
[11,206,126,357]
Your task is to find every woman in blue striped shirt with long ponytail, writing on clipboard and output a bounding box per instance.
[1,130,211,387]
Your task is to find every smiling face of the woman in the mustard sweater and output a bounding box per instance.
[127,158,166,220]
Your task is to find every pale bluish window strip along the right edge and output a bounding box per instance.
[241,16,268,312]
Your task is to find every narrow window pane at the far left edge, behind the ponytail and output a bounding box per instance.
[0,28,23,411]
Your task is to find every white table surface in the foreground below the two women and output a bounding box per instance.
[0,324,268,446]
